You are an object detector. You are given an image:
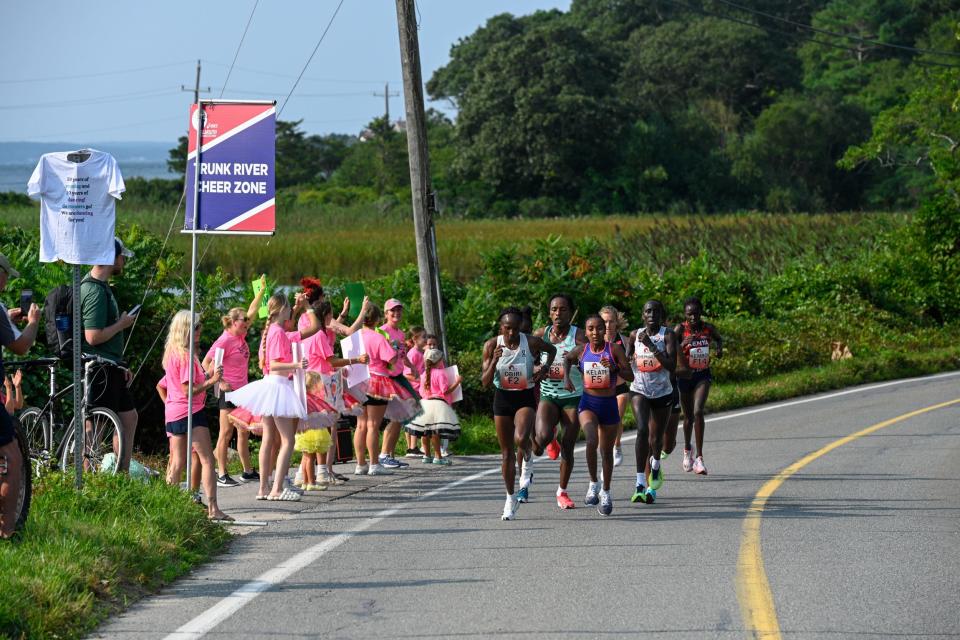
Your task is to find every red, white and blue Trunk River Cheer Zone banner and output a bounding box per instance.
[183,102,276,235]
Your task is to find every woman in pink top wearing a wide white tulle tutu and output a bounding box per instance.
[227,293,319,501]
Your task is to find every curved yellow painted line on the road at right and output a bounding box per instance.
[737,398,960,640]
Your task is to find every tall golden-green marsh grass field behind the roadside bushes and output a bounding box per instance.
[0,203,902,283]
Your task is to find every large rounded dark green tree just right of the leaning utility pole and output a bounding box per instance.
[448,20,620,206]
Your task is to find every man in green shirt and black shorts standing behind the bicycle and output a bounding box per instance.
[80,238,137,471]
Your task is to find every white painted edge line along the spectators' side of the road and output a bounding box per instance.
[165,371,960,640]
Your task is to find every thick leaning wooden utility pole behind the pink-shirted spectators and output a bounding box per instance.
[397,0,447,353]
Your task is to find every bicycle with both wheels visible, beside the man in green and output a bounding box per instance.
[15,355,124,476]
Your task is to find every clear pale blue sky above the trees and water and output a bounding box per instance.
[0,0,570,143]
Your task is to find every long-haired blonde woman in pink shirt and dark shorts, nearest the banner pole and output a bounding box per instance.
[158,310,232,520]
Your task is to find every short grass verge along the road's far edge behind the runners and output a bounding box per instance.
[453,347,960,455]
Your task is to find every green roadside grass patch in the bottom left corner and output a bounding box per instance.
[0,474,230,638]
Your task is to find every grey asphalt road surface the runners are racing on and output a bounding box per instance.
[94,375,960,640]
